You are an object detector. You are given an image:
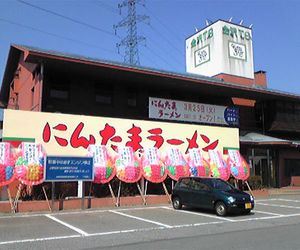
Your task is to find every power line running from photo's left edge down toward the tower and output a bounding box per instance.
[0,18,118,54]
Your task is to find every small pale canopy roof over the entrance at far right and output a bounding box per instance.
[240,133,300,147]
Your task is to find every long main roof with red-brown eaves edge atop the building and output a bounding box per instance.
[0,45,300,103]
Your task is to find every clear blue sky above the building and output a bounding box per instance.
[0,0,300,95]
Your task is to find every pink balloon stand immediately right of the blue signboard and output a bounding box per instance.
[88,145,116,184]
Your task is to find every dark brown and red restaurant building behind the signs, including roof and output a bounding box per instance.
[0,42,300,187]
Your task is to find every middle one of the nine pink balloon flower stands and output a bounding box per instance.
[141,147,167,183]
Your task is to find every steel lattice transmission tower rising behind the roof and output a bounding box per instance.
[114,0,149,65]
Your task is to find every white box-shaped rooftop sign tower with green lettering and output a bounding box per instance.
[186,20,254,79]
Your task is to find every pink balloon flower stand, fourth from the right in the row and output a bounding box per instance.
[165,148,190,181]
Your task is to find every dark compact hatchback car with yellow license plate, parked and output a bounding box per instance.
[172,177,254,216]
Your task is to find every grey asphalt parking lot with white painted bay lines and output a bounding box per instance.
[0,195,300,249]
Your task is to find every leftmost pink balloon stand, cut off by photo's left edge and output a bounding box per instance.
[0,142,15,186]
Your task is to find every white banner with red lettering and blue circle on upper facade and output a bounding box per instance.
[149,97,239,126]
